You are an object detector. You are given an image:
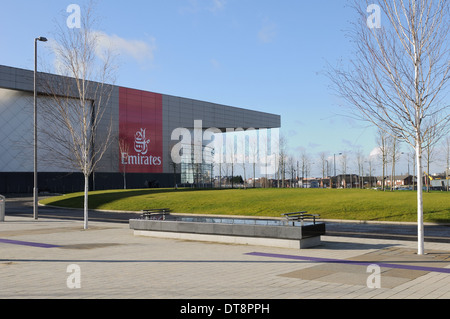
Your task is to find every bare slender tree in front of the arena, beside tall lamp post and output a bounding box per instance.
[42,4,115,229]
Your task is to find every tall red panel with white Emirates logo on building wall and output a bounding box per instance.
[119,88,163,173]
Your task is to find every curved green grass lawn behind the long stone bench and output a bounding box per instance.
[40,188,450,223]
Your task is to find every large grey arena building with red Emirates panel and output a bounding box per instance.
[0,65,281,193]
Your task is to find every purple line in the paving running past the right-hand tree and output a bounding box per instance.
[246,252,450,274]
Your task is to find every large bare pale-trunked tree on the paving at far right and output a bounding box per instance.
[330,0,450,255]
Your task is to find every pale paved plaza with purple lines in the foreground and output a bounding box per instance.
[0,216,450,299]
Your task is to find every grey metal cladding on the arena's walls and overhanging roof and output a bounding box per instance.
[0,65,281,176]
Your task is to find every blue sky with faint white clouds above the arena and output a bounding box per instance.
[0,0,446,175]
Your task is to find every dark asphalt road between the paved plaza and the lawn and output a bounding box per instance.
[1,197,450,243]
